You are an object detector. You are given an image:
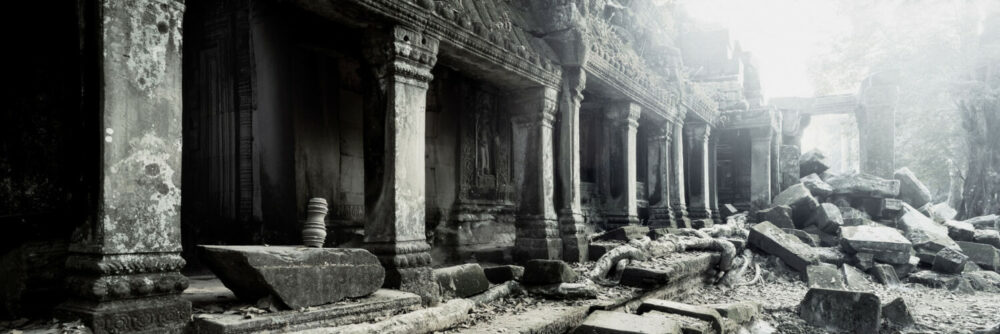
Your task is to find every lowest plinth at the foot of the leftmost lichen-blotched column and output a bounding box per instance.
[56,295,191,334]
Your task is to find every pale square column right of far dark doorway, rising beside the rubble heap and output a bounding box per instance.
[750,127,772,209]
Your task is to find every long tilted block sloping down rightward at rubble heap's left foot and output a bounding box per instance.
[747,222,819,272]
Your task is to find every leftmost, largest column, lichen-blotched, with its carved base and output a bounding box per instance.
[56,0,191,333]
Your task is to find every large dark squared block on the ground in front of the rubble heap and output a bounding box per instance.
[799,288,882,333]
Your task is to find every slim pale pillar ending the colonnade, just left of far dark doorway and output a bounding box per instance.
[684,123,712,227]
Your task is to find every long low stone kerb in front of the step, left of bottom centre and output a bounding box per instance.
[192,289,420,334]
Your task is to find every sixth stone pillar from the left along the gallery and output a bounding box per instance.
[646,122,675,227]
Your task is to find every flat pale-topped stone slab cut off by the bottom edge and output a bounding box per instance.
[573,310,681,334]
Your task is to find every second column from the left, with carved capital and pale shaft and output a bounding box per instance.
[365,26,438,304]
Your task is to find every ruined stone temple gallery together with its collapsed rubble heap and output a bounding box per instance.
[7,0,1000,333]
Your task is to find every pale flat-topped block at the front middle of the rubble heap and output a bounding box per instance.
[840,226,913,264]
